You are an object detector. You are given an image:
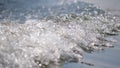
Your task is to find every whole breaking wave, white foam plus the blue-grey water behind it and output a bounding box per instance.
[0,0,120,68]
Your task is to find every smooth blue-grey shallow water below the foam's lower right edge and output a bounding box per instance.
[63,37,120,68]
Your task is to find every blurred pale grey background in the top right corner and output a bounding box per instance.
[81,0,120,15]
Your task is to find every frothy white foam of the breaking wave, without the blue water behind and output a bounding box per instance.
[0,2,120,68]
